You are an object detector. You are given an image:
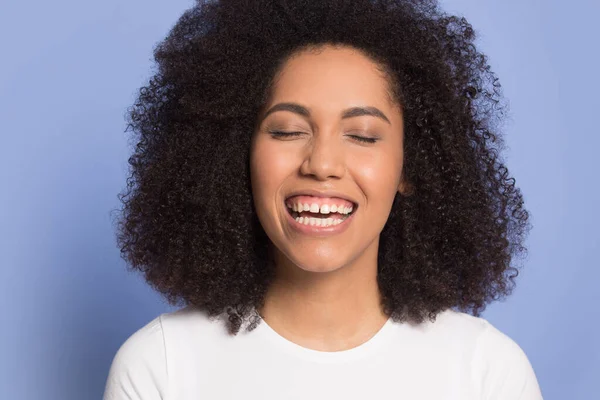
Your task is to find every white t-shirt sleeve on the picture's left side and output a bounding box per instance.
[103,316,167,400]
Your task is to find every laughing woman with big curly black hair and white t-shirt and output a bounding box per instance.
[104,0,542,400]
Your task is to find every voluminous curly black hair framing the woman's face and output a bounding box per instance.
[112,0,531,335]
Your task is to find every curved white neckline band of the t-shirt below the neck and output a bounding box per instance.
[256,317,394,363]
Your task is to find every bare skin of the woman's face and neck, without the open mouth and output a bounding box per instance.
[250,45,405,351]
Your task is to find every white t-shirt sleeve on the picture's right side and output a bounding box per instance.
[473,321,543,400]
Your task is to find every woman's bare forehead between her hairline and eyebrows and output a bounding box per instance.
[272,46,389,110]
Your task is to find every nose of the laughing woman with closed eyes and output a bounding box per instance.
[300,133,346,180]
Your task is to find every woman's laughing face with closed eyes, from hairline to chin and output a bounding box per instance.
[250,46,403,272]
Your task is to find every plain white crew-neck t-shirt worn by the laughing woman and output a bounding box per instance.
[104,306,542,400]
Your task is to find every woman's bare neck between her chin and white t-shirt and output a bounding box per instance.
[260,241,388,351]
